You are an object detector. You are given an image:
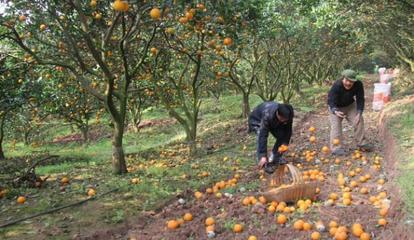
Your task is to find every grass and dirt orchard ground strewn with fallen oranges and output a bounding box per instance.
[0,77,414,239]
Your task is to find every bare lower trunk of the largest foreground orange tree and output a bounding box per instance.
[112,122,127,174]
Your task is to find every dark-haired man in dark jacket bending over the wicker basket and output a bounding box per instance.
[249,102,293,173]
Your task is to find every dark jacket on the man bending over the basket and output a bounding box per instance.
[249,102,293,159]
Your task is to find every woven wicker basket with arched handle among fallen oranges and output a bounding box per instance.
[260,164,318,202]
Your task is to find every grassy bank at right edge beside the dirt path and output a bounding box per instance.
[389,100,414,216]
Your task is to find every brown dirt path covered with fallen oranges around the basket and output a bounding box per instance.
[88,78,409,240]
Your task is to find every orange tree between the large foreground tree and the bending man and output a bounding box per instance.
[151,2,228,150]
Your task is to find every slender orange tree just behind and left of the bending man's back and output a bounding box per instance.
[214,1,265,118]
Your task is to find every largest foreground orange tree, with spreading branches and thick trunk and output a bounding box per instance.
[1,0,158,174]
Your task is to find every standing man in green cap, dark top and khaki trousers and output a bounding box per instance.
[328,69,372,155]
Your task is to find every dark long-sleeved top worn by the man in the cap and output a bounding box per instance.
[328,79,365,113]
